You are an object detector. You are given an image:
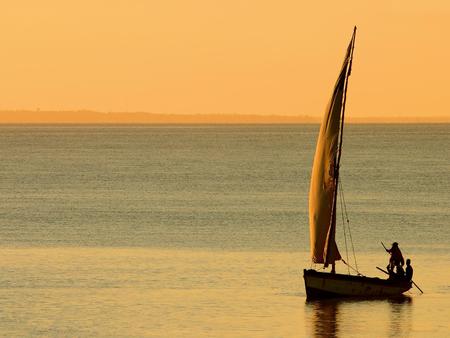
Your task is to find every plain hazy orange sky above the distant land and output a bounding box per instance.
[0,0,450,118]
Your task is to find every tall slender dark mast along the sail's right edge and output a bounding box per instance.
[324,26,356,267]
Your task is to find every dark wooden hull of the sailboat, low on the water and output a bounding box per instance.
[303,269,411,300]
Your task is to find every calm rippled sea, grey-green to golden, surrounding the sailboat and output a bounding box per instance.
[0,124,450,337]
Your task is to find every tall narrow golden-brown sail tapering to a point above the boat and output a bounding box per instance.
[309,28,356,266]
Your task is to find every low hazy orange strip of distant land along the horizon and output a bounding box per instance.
[0,110,450,125]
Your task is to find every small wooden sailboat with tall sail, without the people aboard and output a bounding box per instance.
[303,27,411,300]
